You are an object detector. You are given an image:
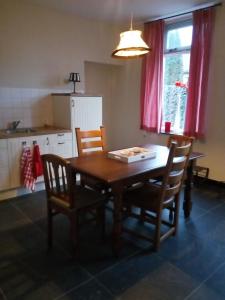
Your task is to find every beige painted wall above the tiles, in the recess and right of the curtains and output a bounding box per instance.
[0,0,225,181]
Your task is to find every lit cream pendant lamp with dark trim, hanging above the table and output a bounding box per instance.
[112,16,151,58]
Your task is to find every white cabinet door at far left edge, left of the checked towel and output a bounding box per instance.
[0,139,10,190]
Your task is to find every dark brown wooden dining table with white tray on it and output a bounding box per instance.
[70,144,204,255]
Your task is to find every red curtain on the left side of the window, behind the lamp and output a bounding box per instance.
[141,20,164,133]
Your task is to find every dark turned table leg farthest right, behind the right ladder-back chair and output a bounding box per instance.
[183,160,194,218]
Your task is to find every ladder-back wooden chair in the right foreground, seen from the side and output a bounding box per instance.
[124,142,191,250]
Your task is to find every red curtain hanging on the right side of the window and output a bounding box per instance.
[184,8,214,138]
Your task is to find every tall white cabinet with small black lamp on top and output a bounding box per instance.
[52,94,102,156]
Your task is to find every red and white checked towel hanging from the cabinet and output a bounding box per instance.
[20,147,36,191]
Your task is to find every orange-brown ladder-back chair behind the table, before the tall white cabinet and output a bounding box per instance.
[75,126,107,193]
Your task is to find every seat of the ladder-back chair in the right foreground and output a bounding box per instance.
[124,183,173,211]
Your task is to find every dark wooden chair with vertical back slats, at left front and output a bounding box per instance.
[42,154,105,249]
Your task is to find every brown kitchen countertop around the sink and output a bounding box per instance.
[0,126,71,139]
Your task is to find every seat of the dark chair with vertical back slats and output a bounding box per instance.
[50,186,105,211]
